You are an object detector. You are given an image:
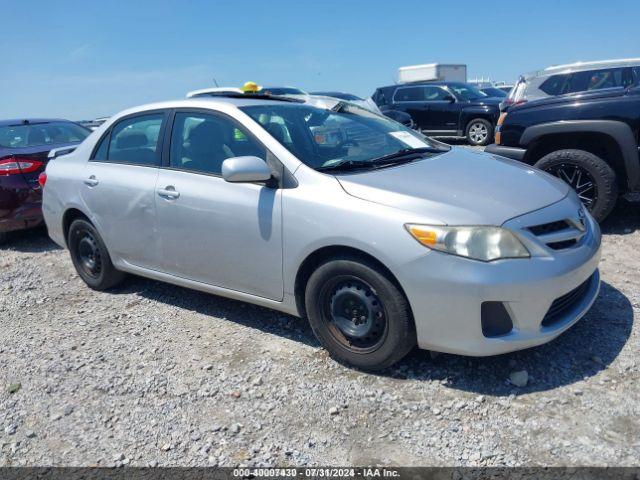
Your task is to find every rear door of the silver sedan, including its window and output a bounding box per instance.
[81,111,167,268]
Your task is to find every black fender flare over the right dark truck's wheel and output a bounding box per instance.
[520,120,640,190]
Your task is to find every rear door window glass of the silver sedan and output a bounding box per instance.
[100,113,164,166]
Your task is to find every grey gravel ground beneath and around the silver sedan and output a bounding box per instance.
[0,190,640,466]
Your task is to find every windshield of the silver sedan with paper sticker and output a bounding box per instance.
[241,102,449,170]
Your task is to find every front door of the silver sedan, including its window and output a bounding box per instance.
[155,111,283,300]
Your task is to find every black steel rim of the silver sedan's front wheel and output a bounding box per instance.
[319,275,388,353]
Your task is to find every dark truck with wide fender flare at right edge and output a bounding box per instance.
[486,80,640,221]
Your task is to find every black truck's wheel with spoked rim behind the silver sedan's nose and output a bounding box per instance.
[535,150,618,222]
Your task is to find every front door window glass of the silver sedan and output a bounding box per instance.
[169,112,266,175]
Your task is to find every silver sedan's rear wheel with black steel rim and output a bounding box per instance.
[67,219,125,290]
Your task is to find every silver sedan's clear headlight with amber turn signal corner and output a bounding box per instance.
[406,224,530,262]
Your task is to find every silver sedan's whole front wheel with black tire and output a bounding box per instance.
[305,256,416,371]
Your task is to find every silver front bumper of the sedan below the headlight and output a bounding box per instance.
[399,200,600,356]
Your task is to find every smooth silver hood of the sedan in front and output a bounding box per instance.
[336,147,569,225]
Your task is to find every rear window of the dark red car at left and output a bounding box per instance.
[0,122,91,148]
